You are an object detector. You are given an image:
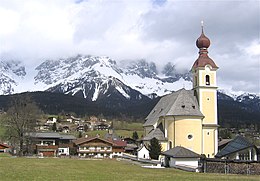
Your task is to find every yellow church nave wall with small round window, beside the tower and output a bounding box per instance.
[173,119,202,154]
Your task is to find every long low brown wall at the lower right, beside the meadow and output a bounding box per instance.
[202,158,260,175]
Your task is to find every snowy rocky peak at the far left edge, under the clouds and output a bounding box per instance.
[0,60,26,95]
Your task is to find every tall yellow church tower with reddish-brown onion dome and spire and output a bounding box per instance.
[192,25,218,158]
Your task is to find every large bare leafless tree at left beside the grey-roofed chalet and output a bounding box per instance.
[4,94,40,156]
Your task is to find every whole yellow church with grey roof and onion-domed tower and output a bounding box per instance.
[143,26,218,158]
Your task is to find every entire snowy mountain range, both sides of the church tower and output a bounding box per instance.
[0,55,260,106]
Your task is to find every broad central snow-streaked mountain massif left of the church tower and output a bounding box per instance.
[35,55,191,101]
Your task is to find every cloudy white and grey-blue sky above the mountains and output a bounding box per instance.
[0,0,260,93]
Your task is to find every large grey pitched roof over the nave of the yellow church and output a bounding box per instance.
[143,89,203,126]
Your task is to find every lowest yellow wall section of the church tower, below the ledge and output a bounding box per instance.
[203,128,216,158]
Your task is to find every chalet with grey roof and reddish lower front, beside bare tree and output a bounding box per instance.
[30,132,76,156]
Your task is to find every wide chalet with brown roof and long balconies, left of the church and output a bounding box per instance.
[74,137,126,158]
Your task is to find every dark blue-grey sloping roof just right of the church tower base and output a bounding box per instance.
[215,136,255,158]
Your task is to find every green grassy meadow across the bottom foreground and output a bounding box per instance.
[0,157,259,181]
